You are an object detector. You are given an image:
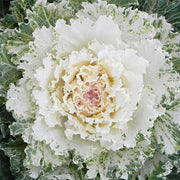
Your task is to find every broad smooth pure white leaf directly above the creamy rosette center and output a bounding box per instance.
[55,16,121,56]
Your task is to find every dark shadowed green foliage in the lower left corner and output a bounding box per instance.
[0,106,26,180]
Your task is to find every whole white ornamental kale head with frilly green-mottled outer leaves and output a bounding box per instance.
[3,1,180,179]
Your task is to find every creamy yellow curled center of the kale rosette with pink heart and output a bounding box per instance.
[64,64,110,117]
